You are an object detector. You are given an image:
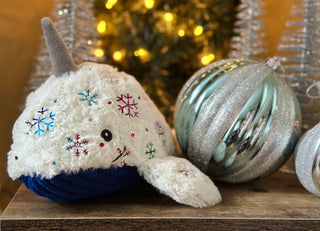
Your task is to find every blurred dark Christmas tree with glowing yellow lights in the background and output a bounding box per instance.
[95,0,238,123]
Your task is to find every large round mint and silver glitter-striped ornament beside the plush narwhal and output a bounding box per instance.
[175,59,301,183]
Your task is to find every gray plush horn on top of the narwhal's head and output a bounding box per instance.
[41,18,78,77]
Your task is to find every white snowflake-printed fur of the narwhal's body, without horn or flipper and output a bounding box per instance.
[8,63,174,179]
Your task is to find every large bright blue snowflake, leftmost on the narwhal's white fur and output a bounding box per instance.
[26,107,56,136]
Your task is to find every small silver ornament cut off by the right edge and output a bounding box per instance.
[294,123,320,196]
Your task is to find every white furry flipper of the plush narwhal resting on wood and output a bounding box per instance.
[138,157,221,208]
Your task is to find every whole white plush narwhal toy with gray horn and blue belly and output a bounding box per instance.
[8,18,221,207]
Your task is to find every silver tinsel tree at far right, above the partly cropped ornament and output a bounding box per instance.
[278,0,320,133]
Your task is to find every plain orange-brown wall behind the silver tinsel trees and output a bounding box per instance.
[0,0,295,214]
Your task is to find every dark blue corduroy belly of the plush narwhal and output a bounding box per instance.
[20,166,142,202]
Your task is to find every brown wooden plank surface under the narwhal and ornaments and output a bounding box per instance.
[1,172,320,230]
